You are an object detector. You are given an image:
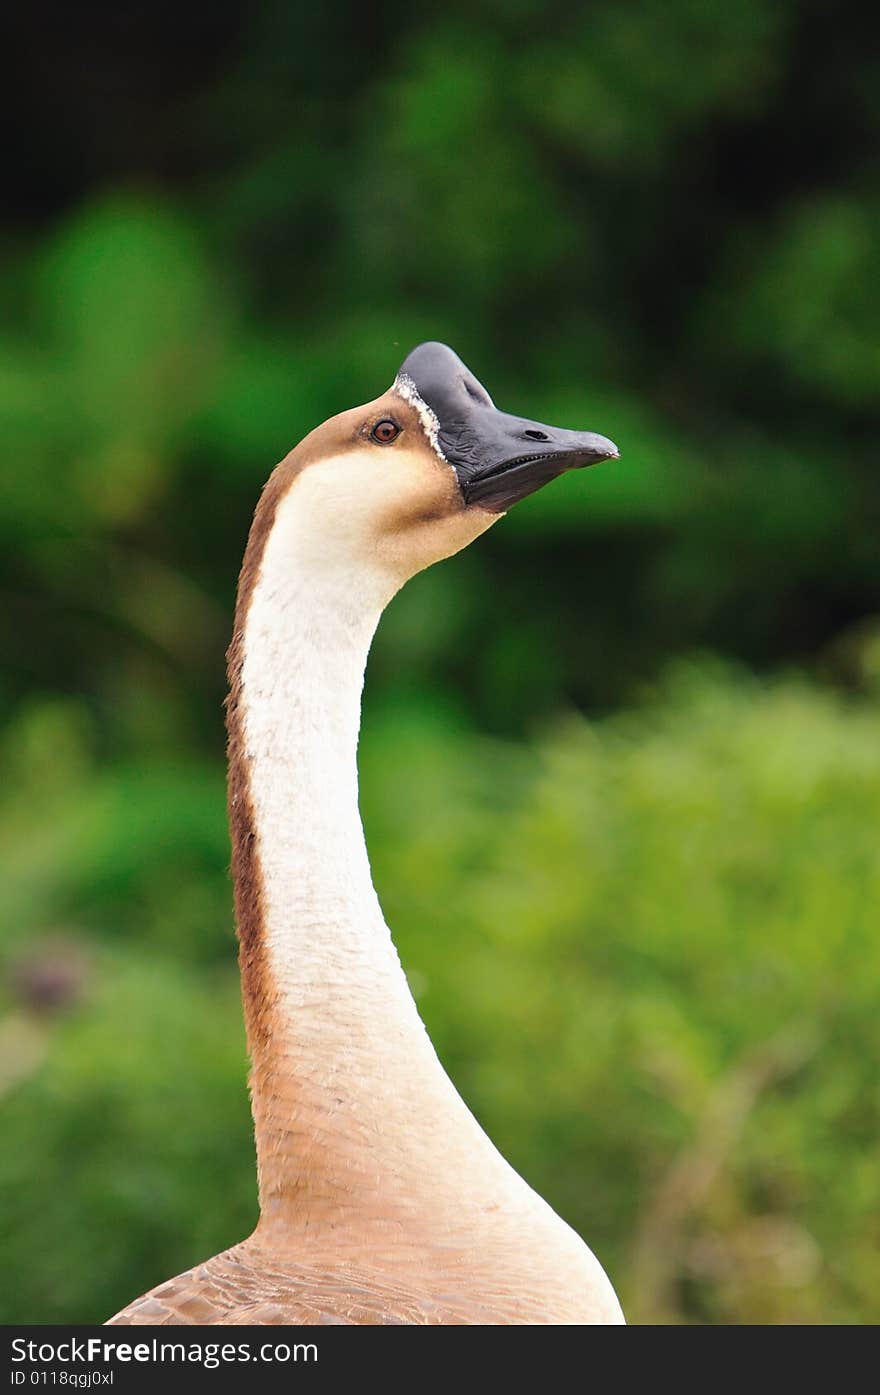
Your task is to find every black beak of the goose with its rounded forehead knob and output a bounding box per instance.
[396,343,619,513]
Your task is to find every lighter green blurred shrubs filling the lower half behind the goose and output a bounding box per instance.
[0,665,880,1322]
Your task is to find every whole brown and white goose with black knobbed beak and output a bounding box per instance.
[110,343,623,1325]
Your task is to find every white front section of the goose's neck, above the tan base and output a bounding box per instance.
[243,488,409,1037]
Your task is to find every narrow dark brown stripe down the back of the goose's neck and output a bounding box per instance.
[226,451,307,1057]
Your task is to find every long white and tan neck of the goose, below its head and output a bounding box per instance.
[229,485,502,1226]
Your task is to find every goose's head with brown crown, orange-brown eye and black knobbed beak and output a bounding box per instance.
[271,343,618,594]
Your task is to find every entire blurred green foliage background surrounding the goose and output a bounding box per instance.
[0,0,880,1322]
